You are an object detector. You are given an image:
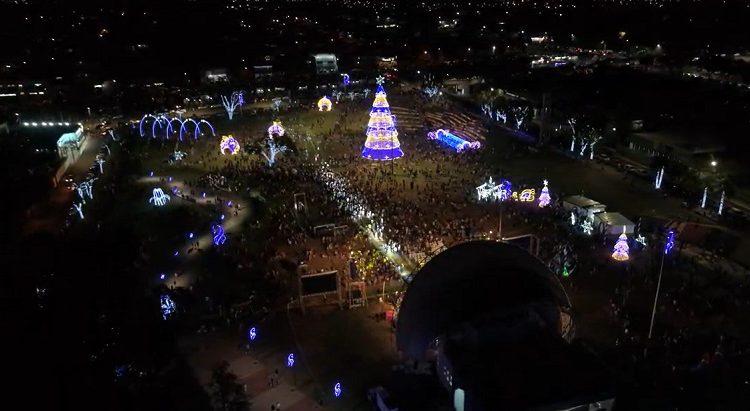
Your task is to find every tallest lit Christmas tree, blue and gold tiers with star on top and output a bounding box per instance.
[362,77,404,160]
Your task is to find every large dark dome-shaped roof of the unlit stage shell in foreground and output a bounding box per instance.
[396,240,573,359]
